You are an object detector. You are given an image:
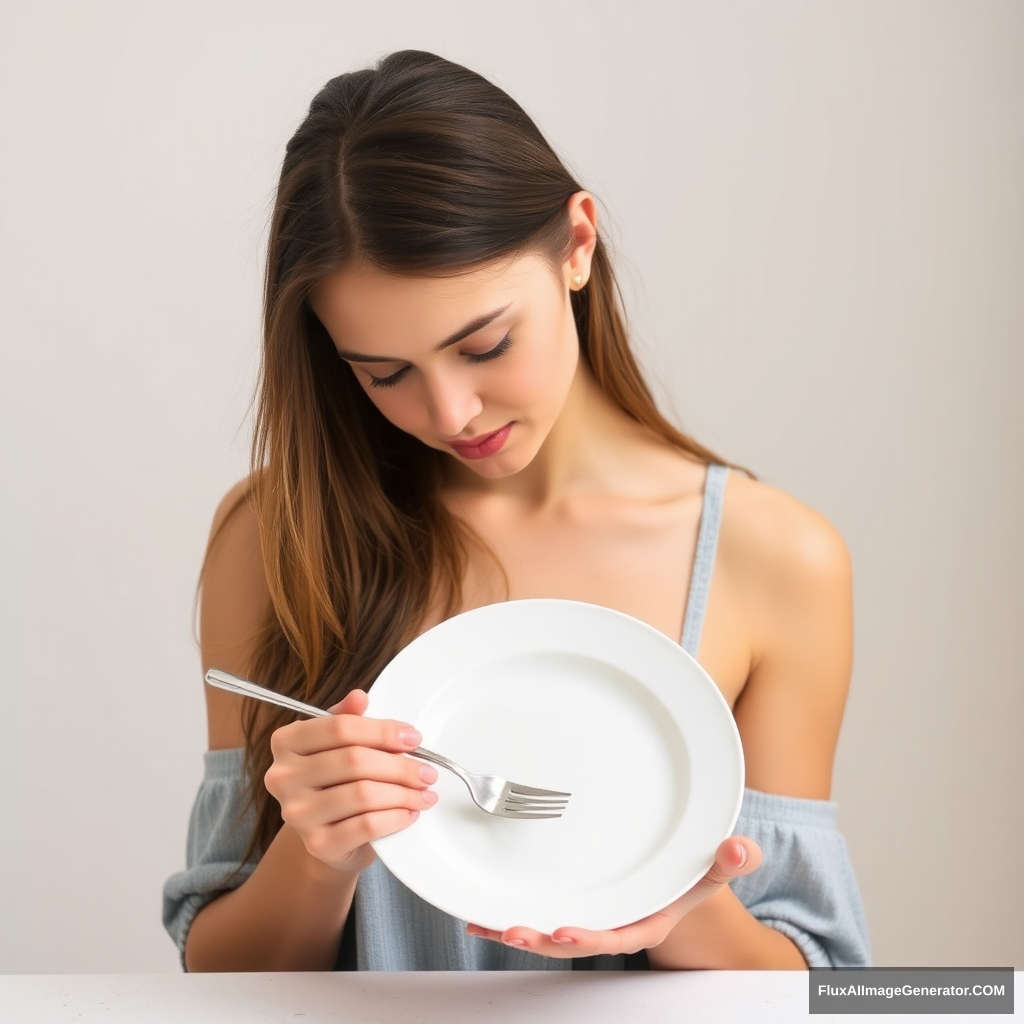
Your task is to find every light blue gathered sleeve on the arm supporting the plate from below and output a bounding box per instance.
[732,790,870,967]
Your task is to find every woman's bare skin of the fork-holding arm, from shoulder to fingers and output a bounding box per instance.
[184,484,437,972]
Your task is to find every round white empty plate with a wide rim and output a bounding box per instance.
[368,600,743,933]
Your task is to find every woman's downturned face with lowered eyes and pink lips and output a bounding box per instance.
[310,255,580,478]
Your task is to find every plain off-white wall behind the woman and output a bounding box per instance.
[0,0,1024,972]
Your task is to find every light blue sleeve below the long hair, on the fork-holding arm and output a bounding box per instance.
[164,746,256,967]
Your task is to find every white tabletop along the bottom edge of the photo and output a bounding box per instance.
[0,971,1021,1024]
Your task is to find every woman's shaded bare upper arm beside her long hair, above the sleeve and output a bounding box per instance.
[199,478,270,750]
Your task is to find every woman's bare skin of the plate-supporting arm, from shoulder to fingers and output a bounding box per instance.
[470,476,853,970]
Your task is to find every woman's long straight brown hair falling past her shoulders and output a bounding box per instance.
[228,50,733,854]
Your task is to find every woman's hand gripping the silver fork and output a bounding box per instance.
[264,690,437,873]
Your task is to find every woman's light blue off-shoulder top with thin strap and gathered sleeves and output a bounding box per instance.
[164,466,870,971]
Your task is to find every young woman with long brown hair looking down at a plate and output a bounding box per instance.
[165,51,867,971]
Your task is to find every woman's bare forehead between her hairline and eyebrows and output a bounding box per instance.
[309,256,553,352]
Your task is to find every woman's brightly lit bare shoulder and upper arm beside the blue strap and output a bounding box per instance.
[720,474,853,798]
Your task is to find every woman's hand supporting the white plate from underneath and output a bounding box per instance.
[467,836,761,958]
